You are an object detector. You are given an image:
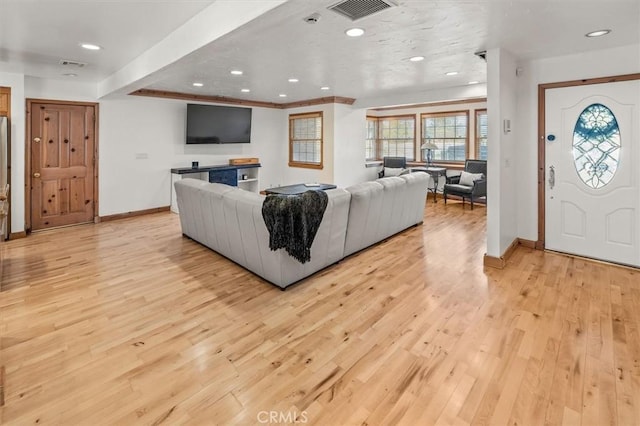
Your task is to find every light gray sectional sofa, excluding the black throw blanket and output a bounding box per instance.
[175,173,429,289]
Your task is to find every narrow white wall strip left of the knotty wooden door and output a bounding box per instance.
[0,72,26,233]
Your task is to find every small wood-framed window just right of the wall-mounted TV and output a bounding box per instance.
[289,112,322,169]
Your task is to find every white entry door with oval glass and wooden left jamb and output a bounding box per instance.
[538,75,640,267]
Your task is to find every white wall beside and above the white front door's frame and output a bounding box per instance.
[516,45,640,241]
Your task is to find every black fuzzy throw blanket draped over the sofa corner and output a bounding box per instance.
[262,191,329,263]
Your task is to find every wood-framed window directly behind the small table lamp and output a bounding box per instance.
[421,111,469,161]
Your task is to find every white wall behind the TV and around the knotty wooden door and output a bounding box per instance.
[6,78,287,228]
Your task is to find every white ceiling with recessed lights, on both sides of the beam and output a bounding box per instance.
[0,0,640,103]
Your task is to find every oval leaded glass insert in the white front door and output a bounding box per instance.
[573,104,620,189]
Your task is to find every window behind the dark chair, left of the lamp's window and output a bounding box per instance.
[378,115,416,161]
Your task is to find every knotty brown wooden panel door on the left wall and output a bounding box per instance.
[29,101,96,231]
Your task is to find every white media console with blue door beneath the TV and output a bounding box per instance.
[171,163,261,213]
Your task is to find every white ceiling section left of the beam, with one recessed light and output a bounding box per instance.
[0,0,213,82]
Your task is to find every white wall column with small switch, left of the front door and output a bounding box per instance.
[487,49,518,257]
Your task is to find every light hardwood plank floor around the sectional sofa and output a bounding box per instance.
[0,200,640,425]
